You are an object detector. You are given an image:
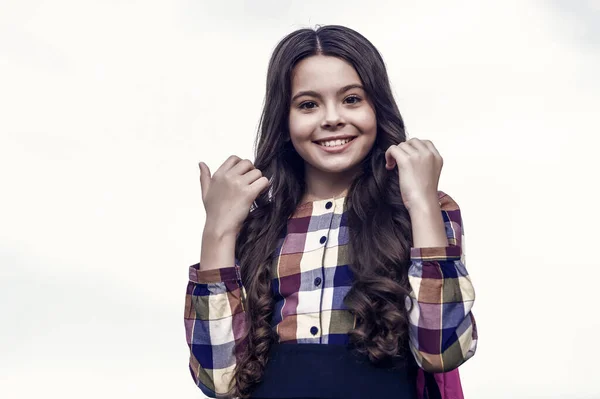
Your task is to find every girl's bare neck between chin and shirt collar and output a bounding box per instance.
[302,165,355,202]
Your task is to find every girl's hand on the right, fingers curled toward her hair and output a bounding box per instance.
[385,138,444,211]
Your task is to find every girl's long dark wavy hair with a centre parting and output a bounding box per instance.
[231,25,412,398]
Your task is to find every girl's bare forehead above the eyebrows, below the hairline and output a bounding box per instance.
[292,55,362,94]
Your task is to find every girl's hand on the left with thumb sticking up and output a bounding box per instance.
[199,155,269,235]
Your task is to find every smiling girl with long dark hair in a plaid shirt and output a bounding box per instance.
[185,26,477,399]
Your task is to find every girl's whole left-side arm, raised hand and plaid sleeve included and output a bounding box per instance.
[190,155,269,397]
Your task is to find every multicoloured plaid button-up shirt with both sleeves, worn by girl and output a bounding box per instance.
[185,191,477,397]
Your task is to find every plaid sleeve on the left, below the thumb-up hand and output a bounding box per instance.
[184,264,246,398]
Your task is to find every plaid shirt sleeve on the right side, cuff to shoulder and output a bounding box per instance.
[407,192,477,373]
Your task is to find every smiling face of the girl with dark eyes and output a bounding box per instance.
[289,55,377,177]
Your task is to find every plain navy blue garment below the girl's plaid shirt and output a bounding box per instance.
[251,343,417,399]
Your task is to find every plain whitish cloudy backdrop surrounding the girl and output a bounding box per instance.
[0,0,600,399]
